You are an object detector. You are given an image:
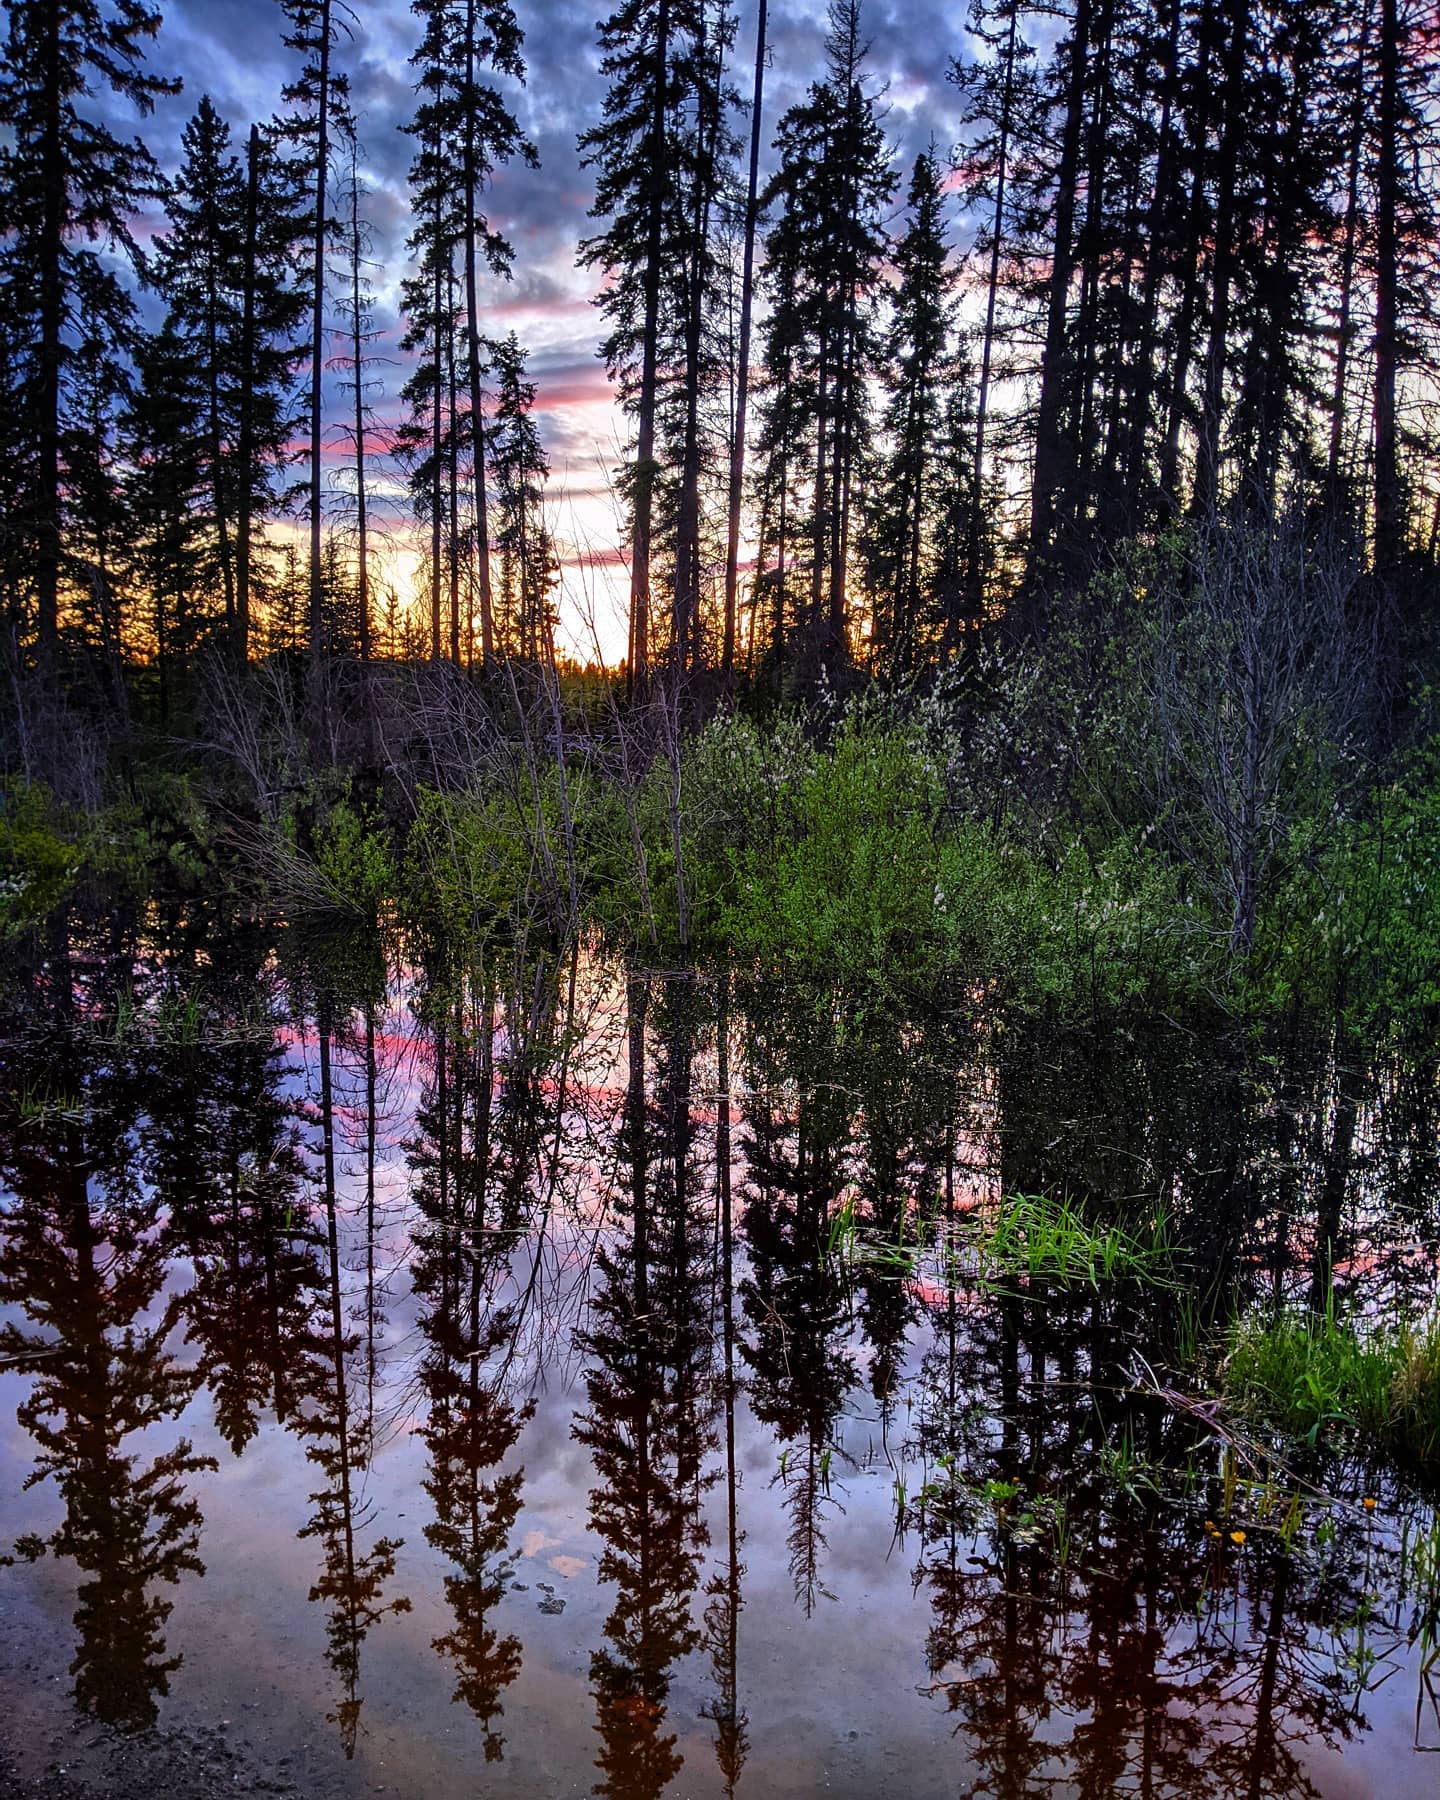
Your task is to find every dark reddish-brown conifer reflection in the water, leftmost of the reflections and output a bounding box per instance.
[0,941,214,1728]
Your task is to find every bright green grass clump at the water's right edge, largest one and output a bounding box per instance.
[1222,1307,1440,1463]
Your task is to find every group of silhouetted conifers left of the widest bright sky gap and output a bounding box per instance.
[0,0,556,705]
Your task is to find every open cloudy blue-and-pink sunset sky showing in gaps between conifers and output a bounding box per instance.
[117,0,967,661]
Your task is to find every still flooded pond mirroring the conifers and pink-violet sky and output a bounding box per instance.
[0,929,1440,1800]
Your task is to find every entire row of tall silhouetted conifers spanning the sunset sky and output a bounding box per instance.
[0,0,1440,734]
